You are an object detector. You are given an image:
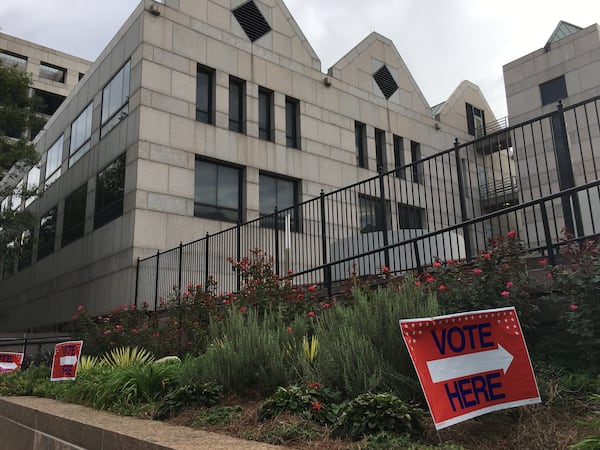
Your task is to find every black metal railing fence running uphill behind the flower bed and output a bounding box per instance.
[135,97,600,308]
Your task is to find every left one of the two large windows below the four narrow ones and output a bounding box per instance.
[194,158,243,223]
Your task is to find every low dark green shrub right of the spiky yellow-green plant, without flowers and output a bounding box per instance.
[154,383,223,420]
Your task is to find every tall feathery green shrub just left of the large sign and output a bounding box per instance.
[303,277,439,399]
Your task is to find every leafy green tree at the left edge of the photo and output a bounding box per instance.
[0,62,44,272]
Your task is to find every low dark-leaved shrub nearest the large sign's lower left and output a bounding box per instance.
[333,393,424,440]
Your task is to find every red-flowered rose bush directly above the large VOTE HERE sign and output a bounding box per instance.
[419,231,536,327]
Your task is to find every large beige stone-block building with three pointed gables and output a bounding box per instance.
[0,0,496,331]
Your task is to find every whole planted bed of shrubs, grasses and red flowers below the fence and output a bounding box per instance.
[0,232,600,449]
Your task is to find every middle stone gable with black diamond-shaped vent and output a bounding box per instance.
[328,32,430,116]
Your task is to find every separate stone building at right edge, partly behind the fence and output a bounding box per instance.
[503,22,600,246]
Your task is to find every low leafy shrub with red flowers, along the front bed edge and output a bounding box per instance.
[258,383,341,424]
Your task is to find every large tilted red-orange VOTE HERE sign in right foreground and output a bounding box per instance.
[400,307,541,430]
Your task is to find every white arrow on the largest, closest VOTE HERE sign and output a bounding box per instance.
[427,344,514,383]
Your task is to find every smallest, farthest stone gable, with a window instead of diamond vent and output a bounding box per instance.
[432,80,497,131]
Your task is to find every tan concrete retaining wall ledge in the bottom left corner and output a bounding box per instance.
[0,397,283,450]
